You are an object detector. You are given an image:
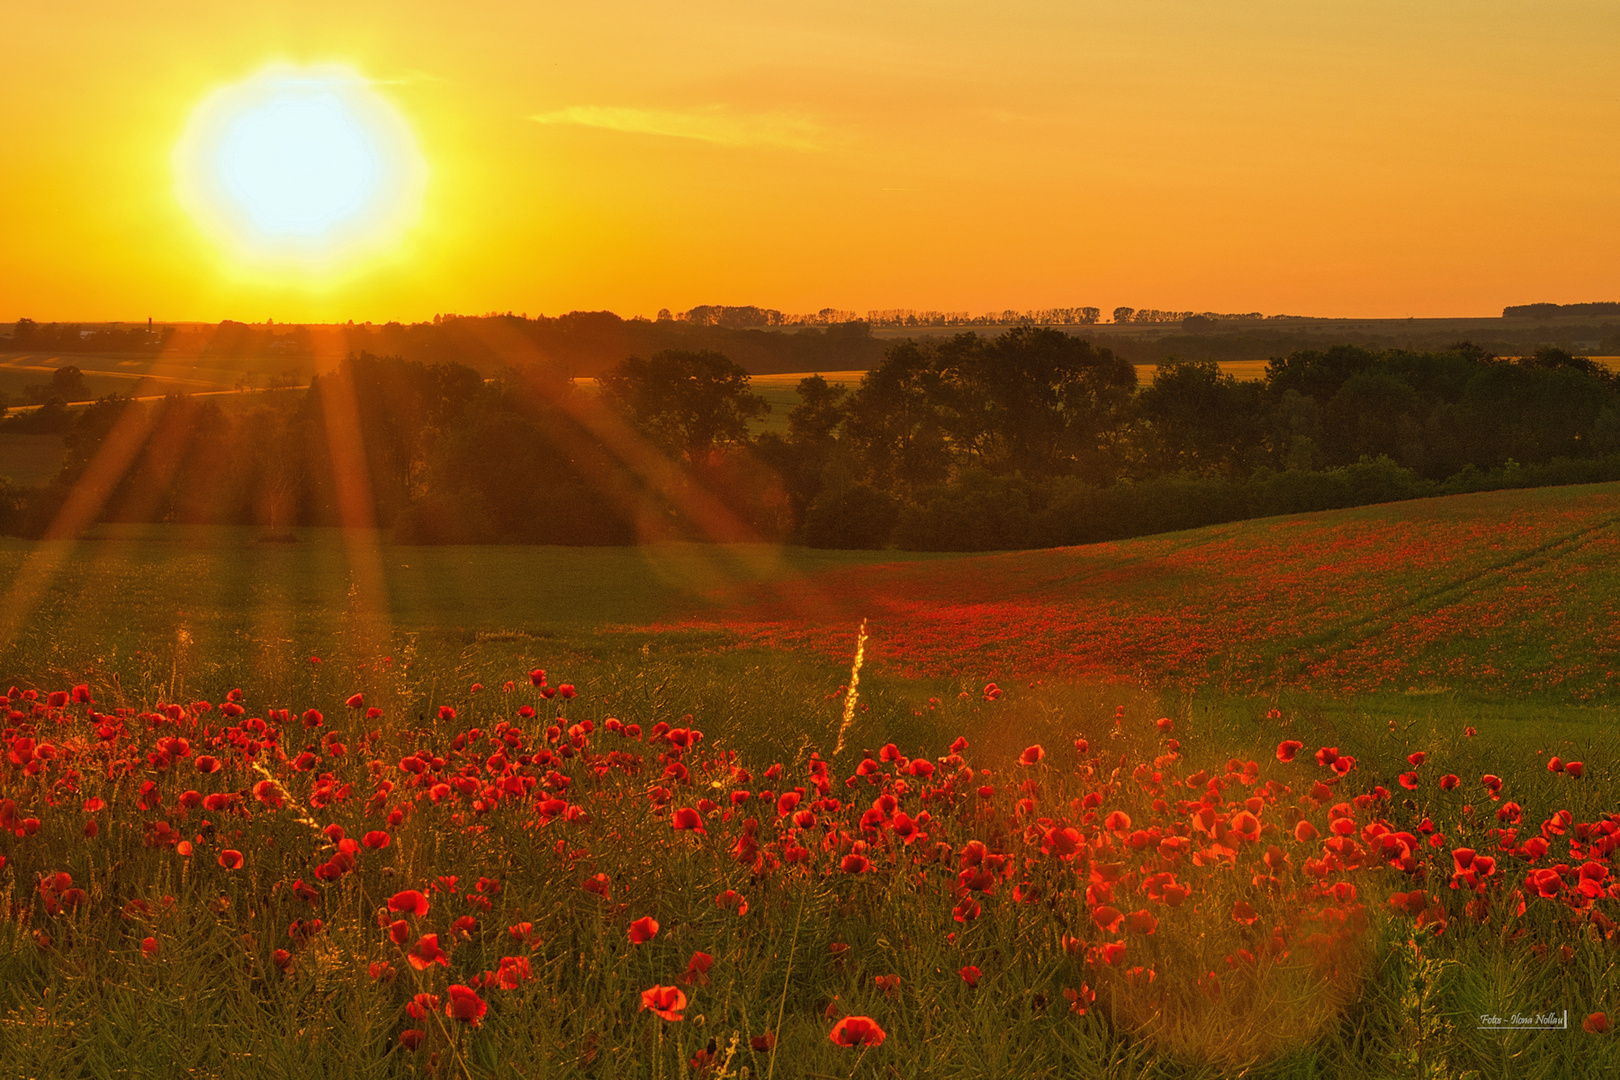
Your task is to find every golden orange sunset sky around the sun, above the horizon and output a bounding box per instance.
[0,0,1620,322]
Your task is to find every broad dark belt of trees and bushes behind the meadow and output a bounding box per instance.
[0,327,1620,549]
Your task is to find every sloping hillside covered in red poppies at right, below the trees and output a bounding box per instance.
[667,484,1620,701]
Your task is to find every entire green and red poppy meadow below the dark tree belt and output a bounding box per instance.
[0,484,1620,1077]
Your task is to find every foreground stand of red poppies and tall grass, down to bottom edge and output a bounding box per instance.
[0,669,1620,1077]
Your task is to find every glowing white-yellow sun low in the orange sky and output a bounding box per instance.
[173,65,428,270]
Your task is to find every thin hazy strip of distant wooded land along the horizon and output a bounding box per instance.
[15,304,1620,382]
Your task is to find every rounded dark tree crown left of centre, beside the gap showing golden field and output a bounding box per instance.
[596,348,771,465]
